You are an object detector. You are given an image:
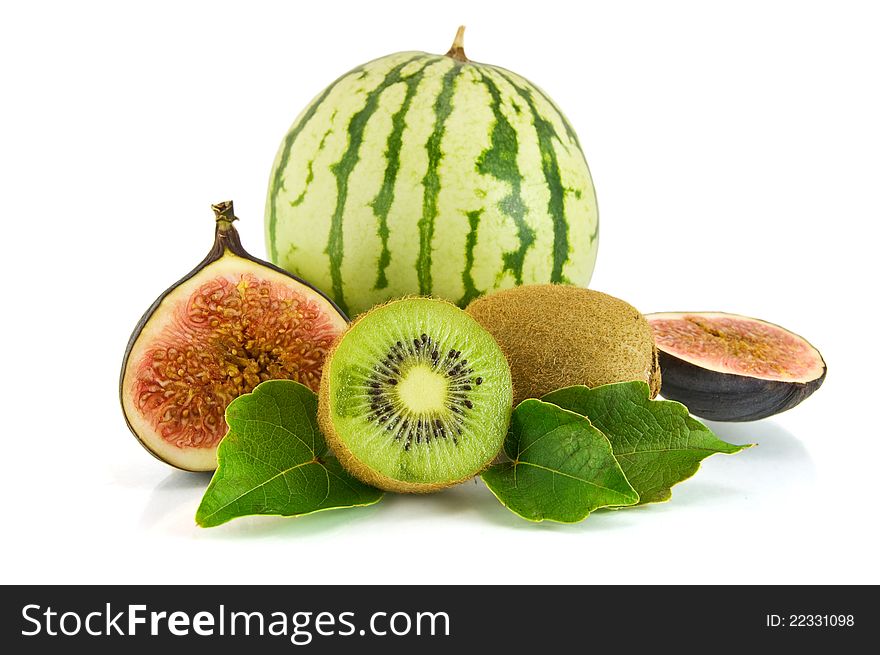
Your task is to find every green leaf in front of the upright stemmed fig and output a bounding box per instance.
[196,380,382,528]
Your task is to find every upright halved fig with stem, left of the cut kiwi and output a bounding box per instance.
[119,201,348,471]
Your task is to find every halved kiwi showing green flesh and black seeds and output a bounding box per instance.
[318,298,513,492]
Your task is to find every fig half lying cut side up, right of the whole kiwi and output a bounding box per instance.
[645,312,826,421]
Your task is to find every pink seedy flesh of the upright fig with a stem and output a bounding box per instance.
[133,273,339,448]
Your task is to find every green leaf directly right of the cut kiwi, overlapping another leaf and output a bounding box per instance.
[482,400,639,523]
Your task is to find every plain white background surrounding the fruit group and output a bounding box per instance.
[0,0,880,583]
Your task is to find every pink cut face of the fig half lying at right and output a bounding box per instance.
[647,313,824,382]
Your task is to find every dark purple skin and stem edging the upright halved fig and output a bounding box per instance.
[119,200,348,473]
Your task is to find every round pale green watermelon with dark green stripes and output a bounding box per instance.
[266,29,599,316]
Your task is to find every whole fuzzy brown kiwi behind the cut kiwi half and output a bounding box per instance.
[466,284,660,403]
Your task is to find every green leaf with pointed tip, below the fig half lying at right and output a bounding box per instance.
[543,382,753,504]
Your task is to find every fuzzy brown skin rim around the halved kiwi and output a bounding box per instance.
[318,296,513,494]
